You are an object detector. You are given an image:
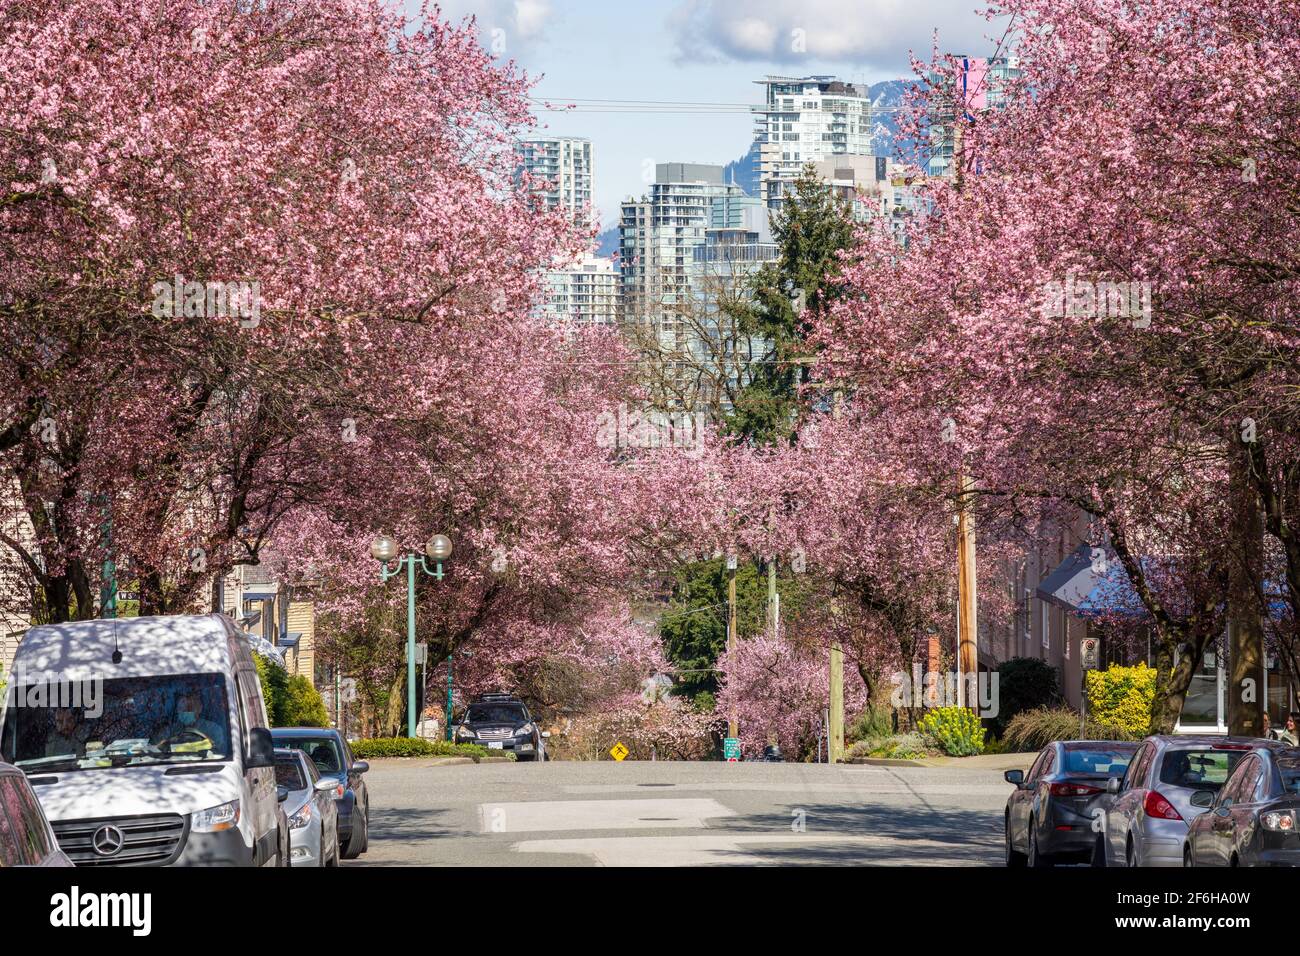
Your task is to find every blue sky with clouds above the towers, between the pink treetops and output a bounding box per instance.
[406,0,1005,228]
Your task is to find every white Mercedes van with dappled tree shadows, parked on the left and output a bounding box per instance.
[0,614,289,866]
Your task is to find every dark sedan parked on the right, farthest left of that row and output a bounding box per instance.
[1002,740,1138,866]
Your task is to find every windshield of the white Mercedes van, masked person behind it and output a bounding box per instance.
[0,674,230,773]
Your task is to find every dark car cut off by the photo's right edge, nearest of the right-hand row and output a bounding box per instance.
[1183,747,1300,866]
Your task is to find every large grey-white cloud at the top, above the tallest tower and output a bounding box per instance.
[668,0,1005,72]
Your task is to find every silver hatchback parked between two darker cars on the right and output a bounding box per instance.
[1096,735,1286,866]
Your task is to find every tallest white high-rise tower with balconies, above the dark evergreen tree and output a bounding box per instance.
[753,75,874,211]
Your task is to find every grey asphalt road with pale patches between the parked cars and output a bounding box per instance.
[345,761,1009,866]
